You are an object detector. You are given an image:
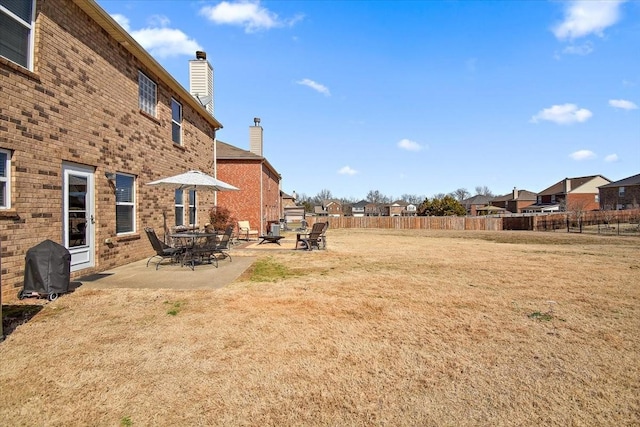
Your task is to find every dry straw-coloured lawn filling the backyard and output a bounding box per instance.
[0,230,640,426]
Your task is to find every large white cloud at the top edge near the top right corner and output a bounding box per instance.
[552,0,626,40]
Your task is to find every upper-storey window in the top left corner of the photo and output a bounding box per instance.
[0,0,35,68]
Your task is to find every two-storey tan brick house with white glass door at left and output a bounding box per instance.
[0,0,222,301]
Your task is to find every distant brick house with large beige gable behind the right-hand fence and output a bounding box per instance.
[524,175,611,212]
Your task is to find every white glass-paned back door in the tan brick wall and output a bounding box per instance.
[62,165,95,271]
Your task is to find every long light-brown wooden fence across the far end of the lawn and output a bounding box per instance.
[307,216,502,231]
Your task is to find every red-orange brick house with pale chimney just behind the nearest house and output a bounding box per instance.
[216,118,283,233]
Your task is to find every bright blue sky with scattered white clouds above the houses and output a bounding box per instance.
[98,0,640,199]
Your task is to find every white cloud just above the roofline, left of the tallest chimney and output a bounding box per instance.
[131,28,203,58]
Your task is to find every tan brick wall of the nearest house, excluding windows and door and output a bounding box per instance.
[0,0,218,301]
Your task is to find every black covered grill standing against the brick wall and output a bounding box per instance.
[24,240,71,294]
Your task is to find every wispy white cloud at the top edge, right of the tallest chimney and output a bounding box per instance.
[200,1,303,33]
